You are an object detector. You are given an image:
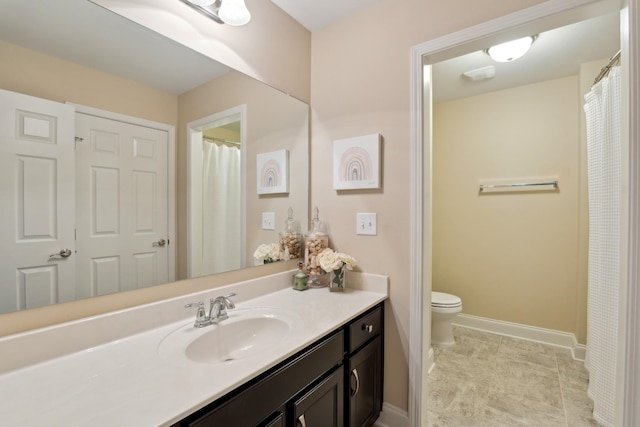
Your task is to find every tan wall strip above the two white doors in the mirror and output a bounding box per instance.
[0,40,178,126]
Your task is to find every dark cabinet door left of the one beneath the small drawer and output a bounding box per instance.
[292,366,344,427]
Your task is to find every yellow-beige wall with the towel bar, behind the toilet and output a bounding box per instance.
[432,76,586,343]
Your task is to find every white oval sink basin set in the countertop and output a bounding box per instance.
[158,307,298,363]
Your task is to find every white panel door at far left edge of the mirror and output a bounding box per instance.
[0,90,75,313]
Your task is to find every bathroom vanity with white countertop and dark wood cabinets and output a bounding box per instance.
[0,272,388,427]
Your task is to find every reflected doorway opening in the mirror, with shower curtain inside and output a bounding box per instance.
[187,105,246,277]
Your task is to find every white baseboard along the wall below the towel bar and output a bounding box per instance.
[453,313,586,360]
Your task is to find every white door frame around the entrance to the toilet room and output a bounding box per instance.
[409,0,640,427]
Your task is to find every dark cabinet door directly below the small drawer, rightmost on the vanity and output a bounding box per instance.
[348,337,382,427]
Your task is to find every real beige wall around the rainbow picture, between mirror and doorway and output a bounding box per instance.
[311,0,542,409]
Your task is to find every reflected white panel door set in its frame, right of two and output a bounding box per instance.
[76,113,169,297]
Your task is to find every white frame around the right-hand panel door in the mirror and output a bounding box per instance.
[66,102,178,283]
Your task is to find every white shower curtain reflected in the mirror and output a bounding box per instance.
[202,142,242,274]
